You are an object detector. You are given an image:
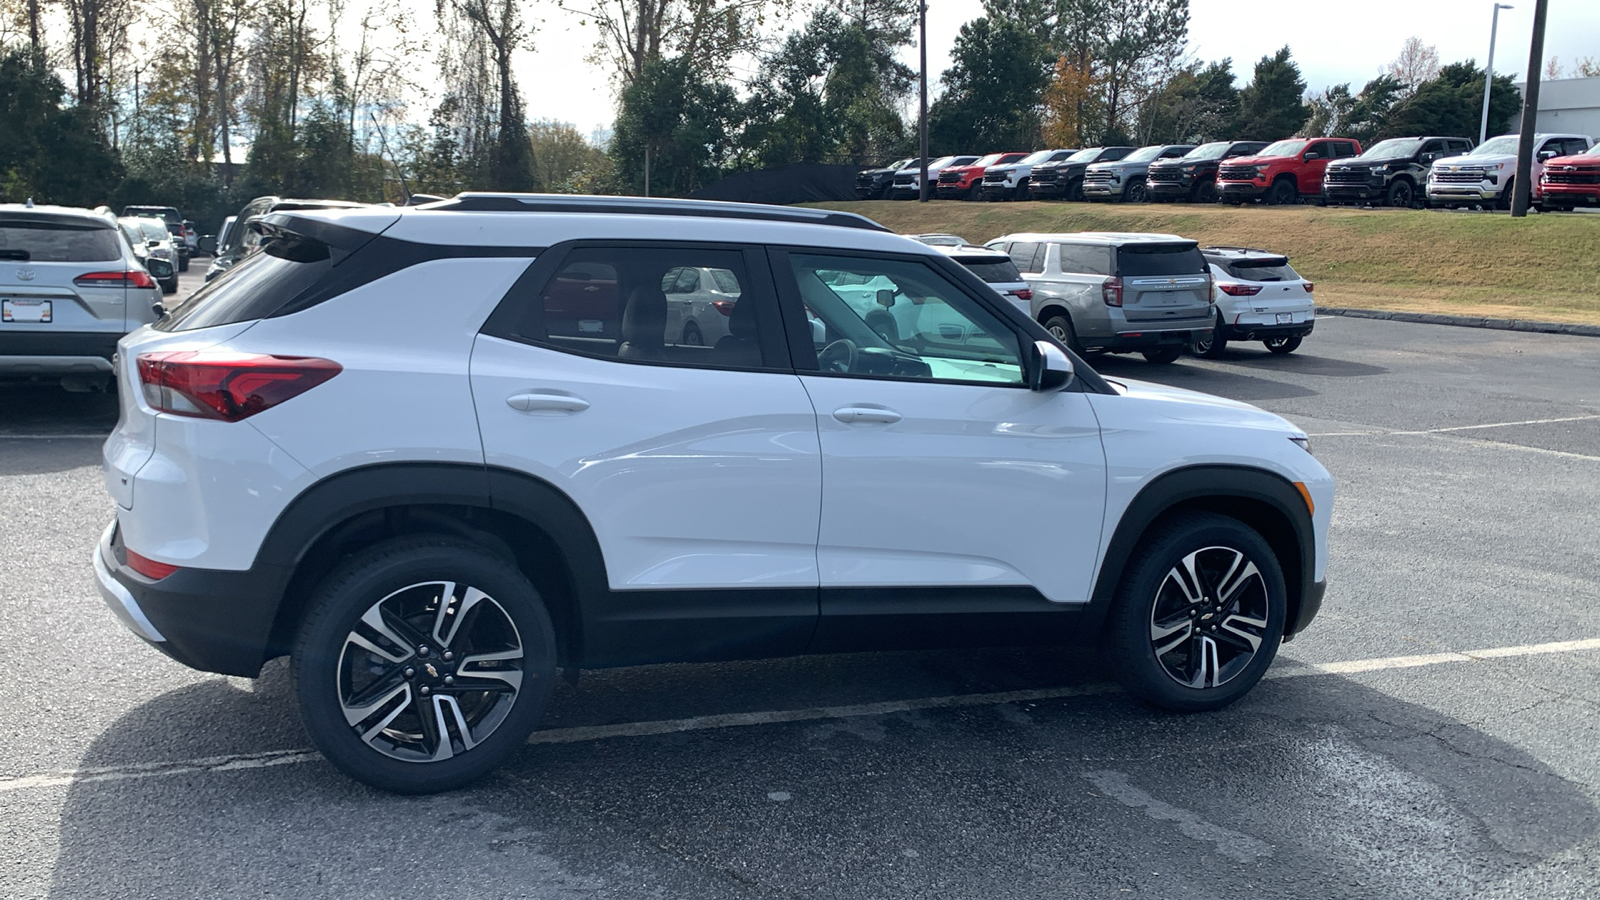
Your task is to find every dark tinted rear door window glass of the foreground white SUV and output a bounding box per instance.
[504,247,778,368]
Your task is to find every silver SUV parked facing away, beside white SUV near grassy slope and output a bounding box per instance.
[986,231,1216,364]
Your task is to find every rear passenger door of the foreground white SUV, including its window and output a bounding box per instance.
[472,242,822,665]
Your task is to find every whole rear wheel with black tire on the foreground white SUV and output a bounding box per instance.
[290,535,555,794]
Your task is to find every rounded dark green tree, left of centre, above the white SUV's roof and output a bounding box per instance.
[611,58,744,197]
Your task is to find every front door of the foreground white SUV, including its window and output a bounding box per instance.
[774,250,1106,645]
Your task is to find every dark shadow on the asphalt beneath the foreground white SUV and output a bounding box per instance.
[43,649,1600,900]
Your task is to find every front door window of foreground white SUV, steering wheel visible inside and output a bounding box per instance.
[789,253,1024,386]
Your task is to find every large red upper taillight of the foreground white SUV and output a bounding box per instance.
[139,351,344,421]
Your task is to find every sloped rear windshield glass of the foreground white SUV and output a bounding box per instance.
[155,240,347,331]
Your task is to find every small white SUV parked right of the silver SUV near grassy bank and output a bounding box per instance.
[1194,247,1317,357]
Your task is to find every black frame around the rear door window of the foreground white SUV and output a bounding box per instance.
[478,237,796,375]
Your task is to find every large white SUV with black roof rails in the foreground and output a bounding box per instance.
[94,194,1333,791]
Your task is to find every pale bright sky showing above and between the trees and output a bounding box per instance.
[512,0,1600,133]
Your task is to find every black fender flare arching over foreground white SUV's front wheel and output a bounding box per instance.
[1083,464,1320,636]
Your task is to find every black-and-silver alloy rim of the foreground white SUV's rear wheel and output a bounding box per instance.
[338,581,523,762]
